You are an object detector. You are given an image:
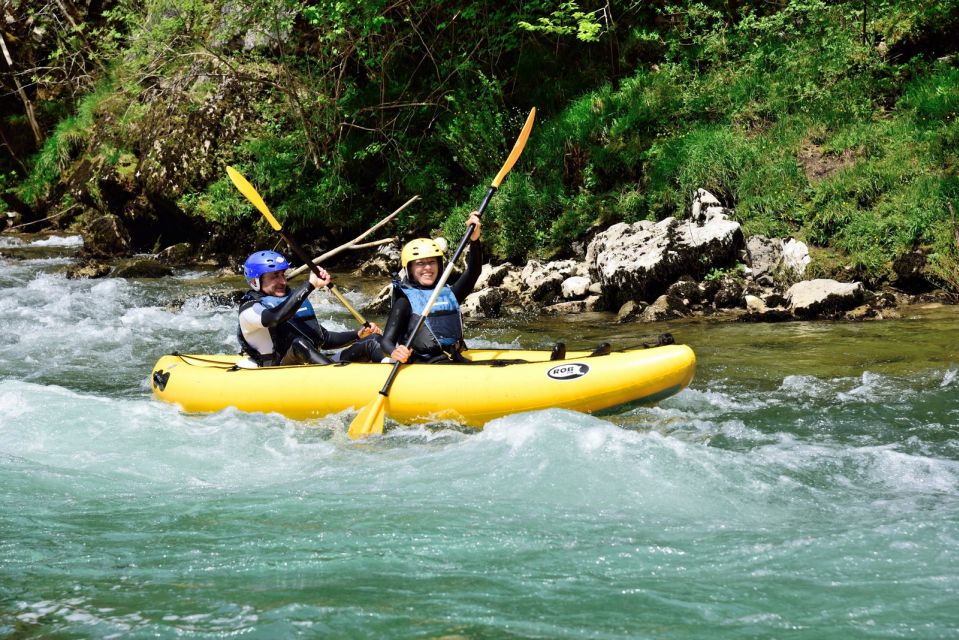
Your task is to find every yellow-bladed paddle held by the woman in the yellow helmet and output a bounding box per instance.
[348,107,536,439]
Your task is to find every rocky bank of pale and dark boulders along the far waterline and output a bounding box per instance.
[5,190,959,323]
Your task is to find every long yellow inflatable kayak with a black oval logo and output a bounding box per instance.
[150,345,696,427]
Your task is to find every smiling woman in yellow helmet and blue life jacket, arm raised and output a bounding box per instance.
[380,211,483,362]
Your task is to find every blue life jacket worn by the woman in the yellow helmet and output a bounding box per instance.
[394,281,463,355]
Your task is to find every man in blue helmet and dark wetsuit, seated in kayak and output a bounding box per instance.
[237,251,382,367]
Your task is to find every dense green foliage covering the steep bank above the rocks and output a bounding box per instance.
[0,0,959,288]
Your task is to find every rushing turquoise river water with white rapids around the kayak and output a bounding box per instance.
[0,236,959,638]
